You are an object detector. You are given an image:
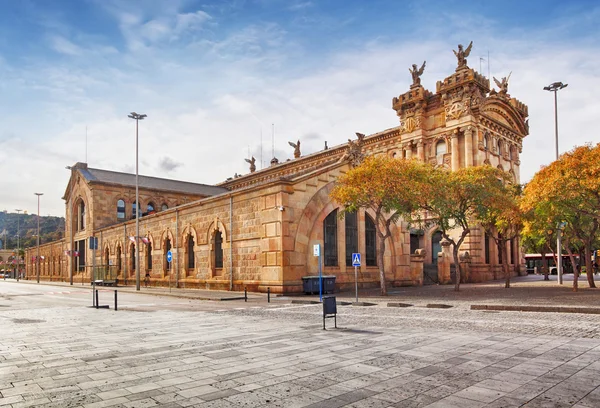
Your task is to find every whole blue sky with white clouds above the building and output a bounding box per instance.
[0,0,600,216]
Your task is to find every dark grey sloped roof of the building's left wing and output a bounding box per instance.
[78,168,229,196]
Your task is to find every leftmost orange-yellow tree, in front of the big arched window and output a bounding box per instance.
[330,156,433,296]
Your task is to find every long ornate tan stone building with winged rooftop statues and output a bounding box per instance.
[26,46,528,293]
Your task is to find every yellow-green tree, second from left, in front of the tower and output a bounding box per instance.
[412,166,504,291]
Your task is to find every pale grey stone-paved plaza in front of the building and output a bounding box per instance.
[0,277,600,408]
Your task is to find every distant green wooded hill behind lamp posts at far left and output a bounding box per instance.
[0,211,65,249]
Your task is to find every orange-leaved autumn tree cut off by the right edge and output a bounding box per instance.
[523,144,600,288]
